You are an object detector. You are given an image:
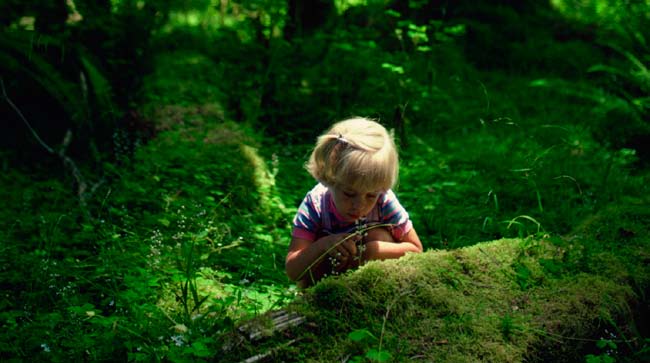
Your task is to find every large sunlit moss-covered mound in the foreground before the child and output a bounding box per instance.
[231,204,650,362]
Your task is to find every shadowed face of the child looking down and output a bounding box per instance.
[332,185,381,222]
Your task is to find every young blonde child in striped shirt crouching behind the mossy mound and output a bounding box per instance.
[286,118,422,287]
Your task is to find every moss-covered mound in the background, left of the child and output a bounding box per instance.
[113,48,282,228]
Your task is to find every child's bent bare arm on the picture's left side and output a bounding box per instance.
[285,233,361,285]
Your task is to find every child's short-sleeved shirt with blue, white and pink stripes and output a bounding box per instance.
[291,183,413,241]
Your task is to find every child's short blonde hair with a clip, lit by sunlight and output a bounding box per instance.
[305,117,399,191]
